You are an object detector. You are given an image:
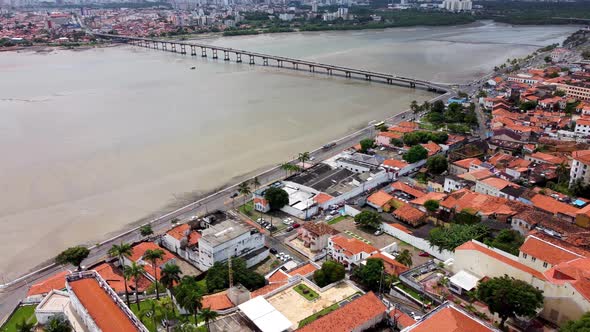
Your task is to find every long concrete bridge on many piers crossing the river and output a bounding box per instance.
[94,34,450,93]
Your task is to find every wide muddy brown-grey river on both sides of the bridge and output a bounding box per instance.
[0,23,576,281]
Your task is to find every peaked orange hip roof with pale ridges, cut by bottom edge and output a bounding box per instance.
[409,304,494,332]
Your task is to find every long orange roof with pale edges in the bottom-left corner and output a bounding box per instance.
[70,278,137,332]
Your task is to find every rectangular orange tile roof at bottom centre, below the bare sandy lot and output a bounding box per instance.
[297,292,387,332]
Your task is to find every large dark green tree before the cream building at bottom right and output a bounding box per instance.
[477,275,543,329]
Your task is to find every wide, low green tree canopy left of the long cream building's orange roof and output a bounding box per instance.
[428,223,490,251]
